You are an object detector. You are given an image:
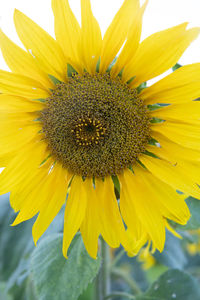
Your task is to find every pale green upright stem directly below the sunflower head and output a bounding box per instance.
[95,239,111,300]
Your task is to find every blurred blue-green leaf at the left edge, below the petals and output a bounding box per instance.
[0,195,34,282]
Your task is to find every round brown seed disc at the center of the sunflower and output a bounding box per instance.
[41,73,150,177]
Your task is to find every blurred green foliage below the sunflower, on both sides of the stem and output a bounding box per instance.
[0,191,200,300]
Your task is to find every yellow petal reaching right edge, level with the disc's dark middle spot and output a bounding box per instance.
[152,121,200,150]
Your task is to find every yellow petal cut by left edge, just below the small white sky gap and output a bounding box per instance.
[0,70,50,99]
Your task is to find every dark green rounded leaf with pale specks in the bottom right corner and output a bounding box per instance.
[140,269,200,300]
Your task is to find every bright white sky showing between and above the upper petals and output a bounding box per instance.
[0,0,200,83]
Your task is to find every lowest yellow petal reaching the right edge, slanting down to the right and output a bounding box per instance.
[140,155,200,198]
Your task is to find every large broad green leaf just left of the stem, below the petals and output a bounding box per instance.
[30,234,100,300]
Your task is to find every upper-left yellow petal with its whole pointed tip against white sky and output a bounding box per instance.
[14,10,67,81]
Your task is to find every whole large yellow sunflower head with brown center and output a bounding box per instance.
[0,0,200,258]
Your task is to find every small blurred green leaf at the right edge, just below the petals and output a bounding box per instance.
[175,197,200,230]
